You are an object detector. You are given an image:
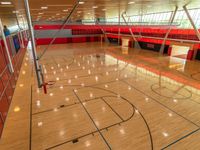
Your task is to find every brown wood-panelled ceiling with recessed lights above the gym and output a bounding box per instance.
[0,0,200,21]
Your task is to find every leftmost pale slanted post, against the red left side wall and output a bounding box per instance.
[0,19,14,73]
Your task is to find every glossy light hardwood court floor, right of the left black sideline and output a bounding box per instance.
[1,43,200,150]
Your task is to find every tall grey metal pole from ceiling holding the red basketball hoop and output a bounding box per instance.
[24,0,43,88]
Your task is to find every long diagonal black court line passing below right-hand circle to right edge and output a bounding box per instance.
[121,80,199,127]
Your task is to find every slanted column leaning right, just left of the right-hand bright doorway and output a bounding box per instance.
[160,6,178,55]
